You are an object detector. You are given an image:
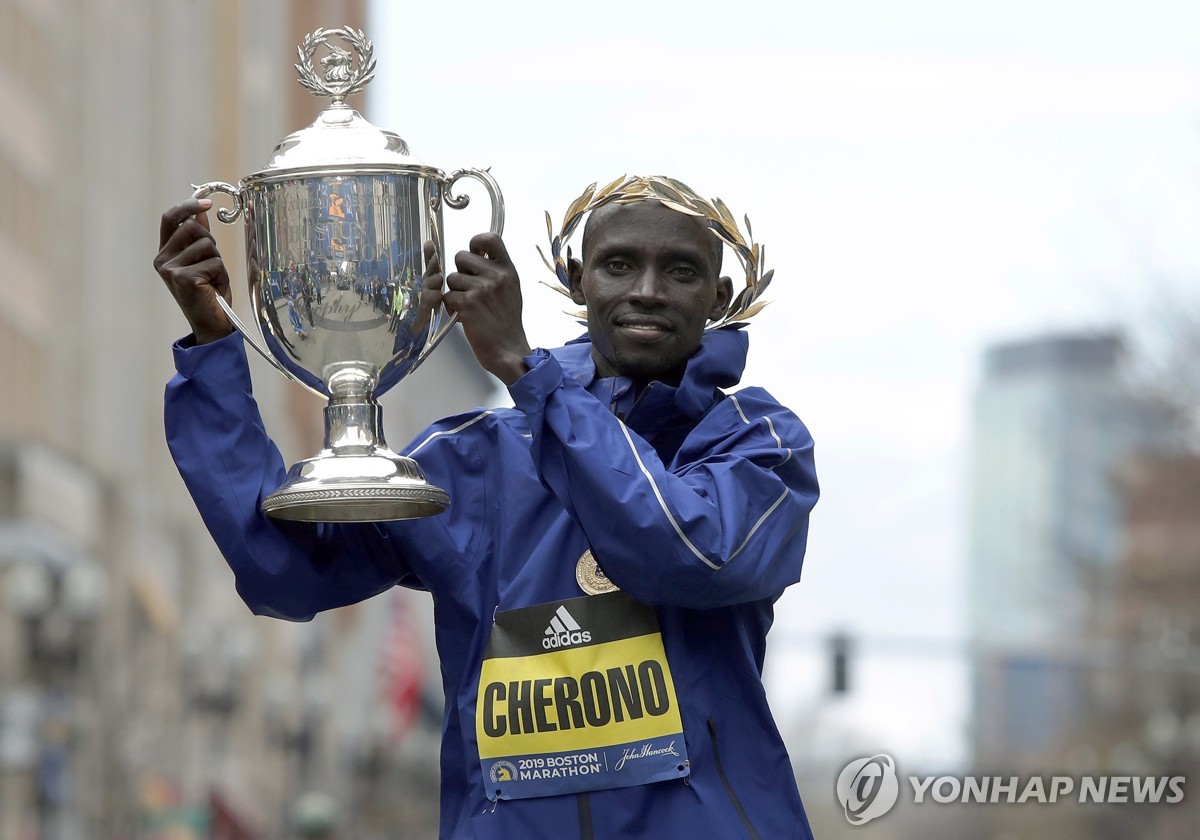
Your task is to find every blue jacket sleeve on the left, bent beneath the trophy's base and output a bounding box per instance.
[166,334,419,620]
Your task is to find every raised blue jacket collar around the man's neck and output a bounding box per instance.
[551,324,750,419]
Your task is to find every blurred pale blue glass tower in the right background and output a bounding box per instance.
[968,332,1178,769]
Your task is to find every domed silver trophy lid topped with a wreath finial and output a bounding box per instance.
[259,26,427,175]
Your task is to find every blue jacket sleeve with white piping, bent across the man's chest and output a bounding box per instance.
[510,354,817,608]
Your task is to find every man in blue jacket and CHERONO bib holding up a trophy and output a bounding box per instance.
[155,177,817,840]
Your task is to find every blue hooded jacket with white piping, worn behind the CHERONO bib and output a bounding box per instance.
[166,329,817,840]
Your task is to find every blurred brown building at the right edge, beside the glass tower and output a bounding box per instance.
[1063,452,1200,838]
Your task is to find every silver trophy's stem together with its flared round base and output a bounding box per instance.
[263,362,450,522]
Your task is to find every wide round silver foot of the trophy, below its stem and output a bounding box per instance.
[263,449,450,522]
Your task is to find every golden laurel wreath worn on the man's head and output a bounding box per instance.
[538,175,775,329]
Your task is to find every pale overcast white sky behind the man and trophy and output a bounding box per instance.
[367,0,1200,767]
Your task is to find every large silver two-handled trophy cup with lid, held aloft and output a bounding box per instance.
[193,26,504,522]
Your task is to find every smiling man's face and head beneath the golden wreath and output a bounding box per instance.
[570,202,732,386]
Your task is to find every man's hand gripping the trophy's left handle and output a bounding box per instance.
[154,198,233,344]
